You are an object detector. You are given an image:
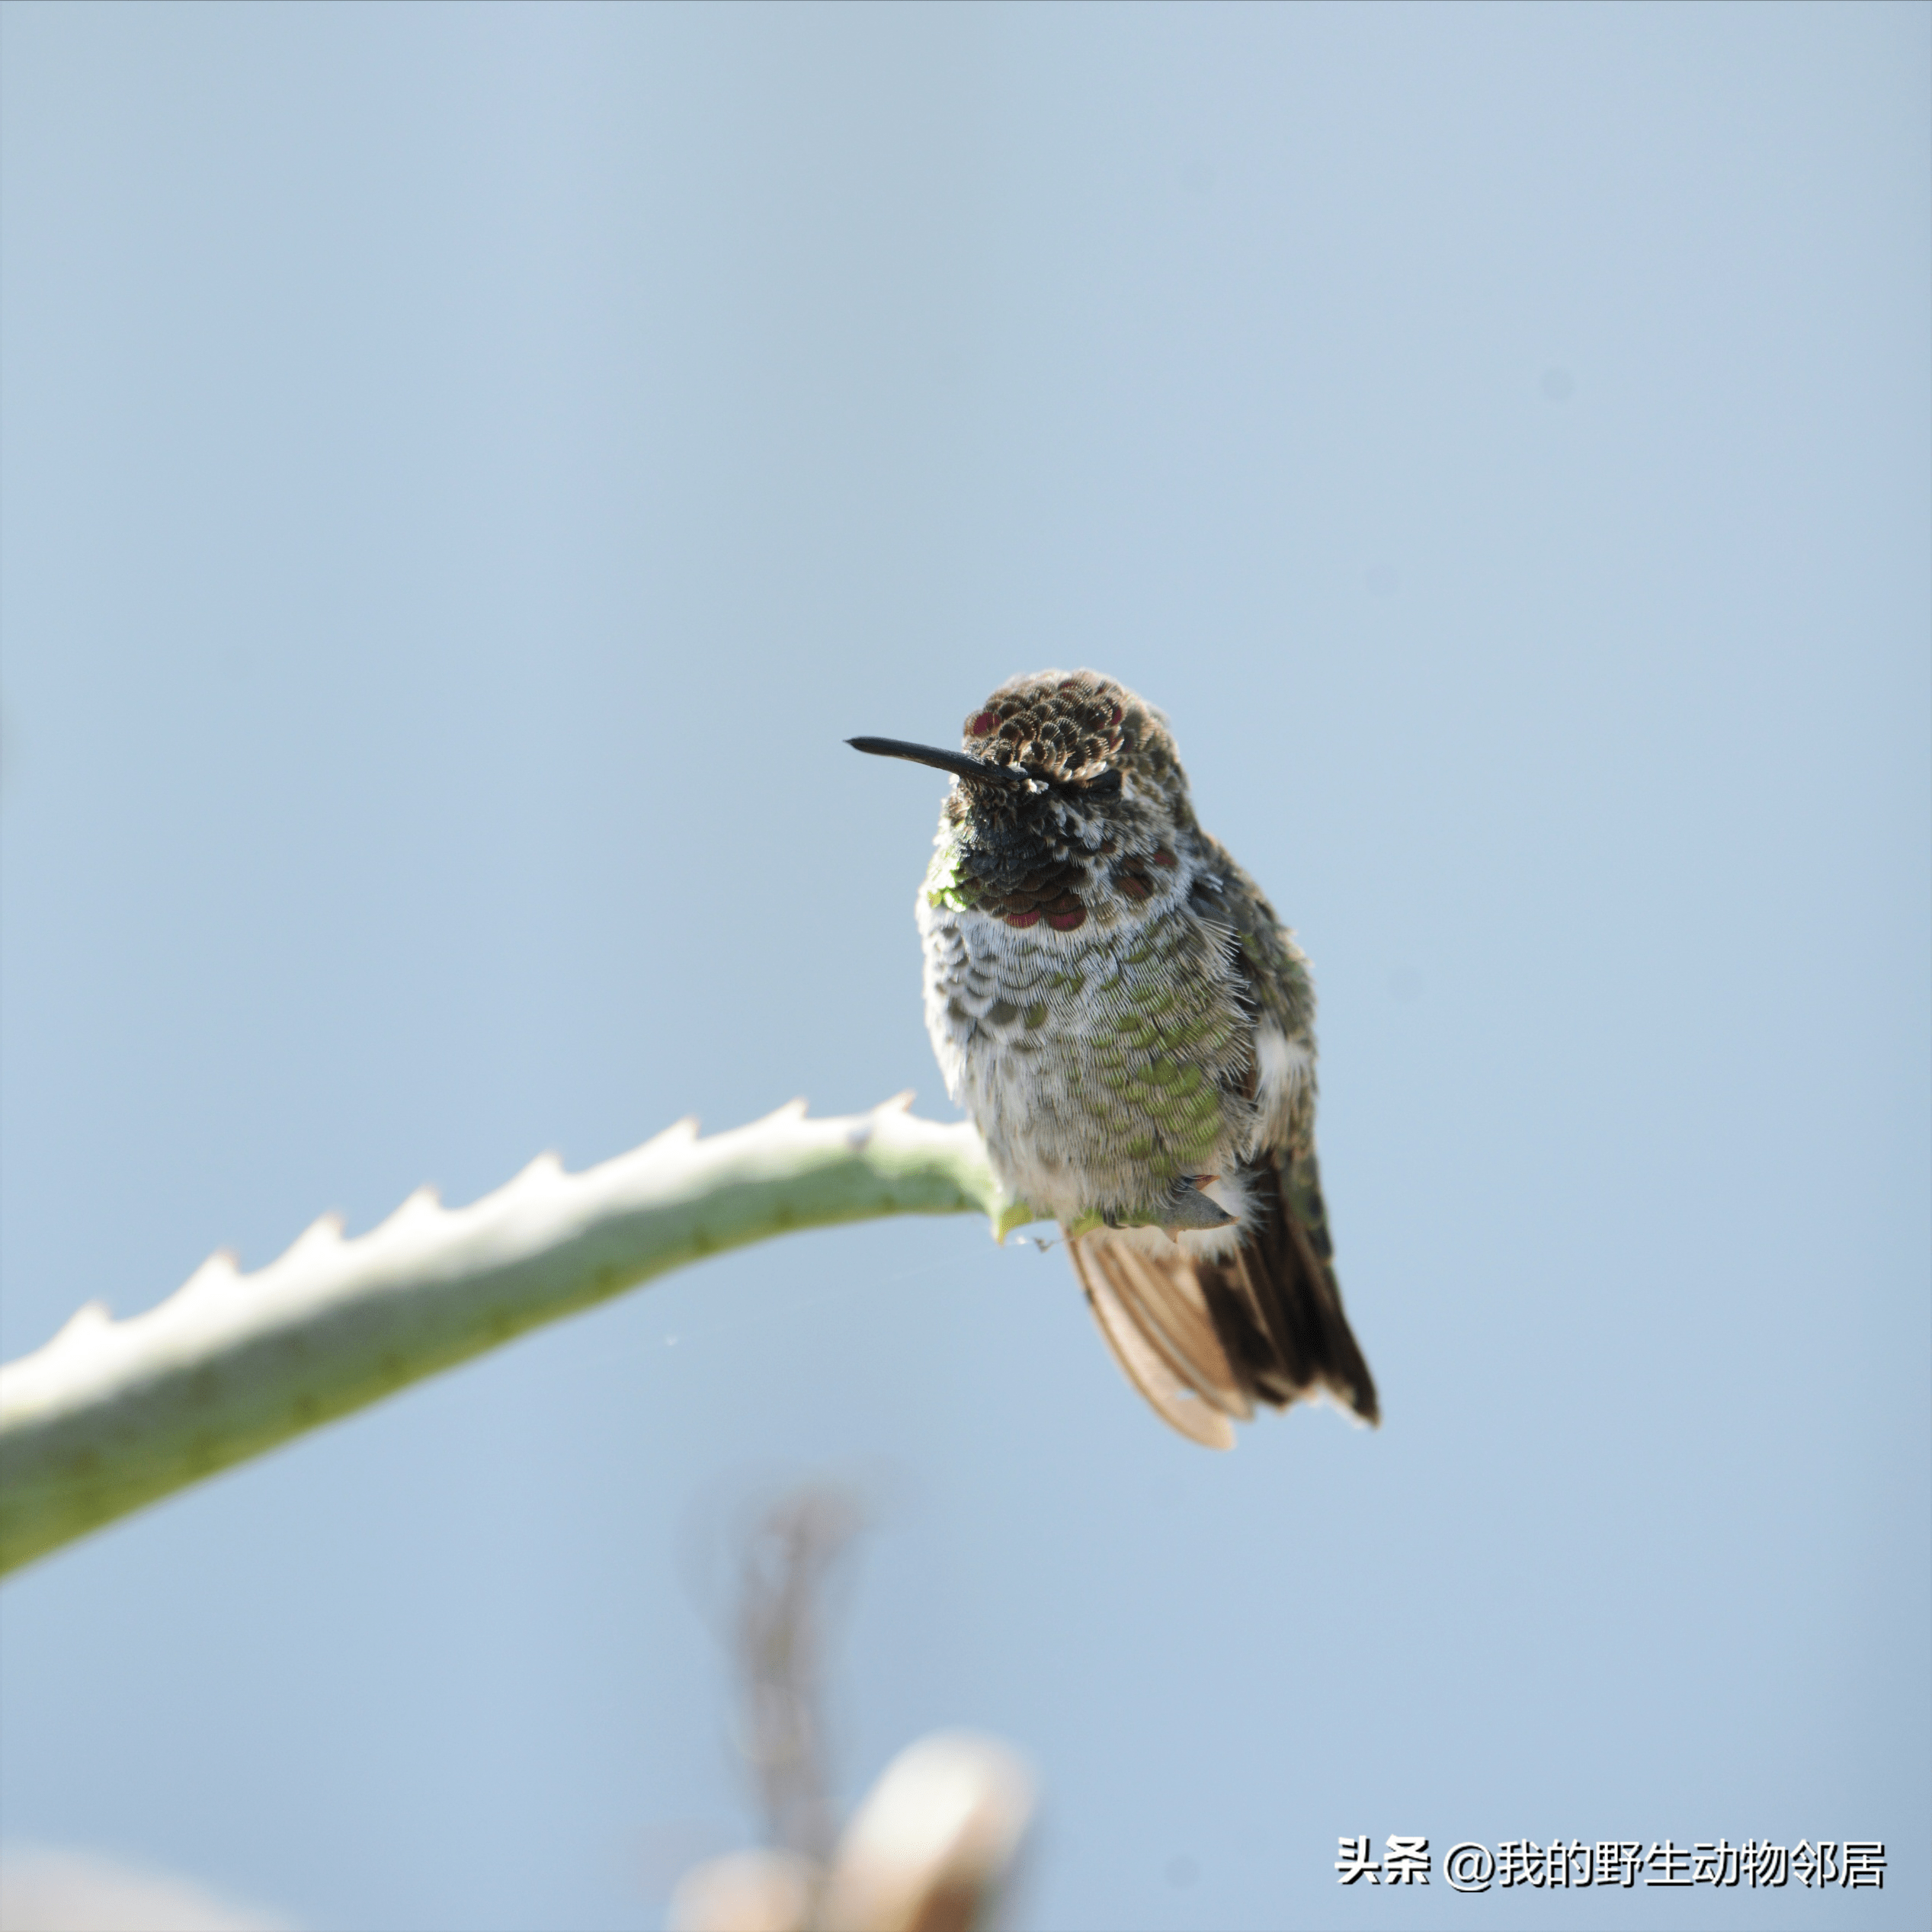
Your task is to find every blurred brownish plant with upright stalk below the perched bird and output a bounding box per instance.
[668,1482,1033,1932]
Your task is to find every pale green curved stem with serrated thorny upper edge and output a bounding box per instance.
[0,1095,1026,1572]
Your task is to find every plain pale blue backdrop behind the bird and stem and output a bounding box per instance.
[0,0,1932,1932]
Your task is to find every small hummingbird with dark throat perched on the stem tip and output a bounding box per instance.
[846,671,1379,1449]
